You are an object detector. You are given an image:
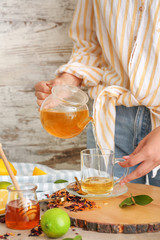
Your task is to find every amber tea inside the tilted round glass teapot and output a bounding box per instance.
[40,109,92,138]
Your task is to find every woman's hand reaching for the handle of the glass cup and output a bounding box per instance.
[119,127,160,185]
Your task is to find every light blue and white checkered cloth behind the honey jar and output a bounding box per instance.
[0,162,80,200]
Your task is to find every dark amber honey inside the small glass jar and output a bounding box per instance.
[5,200,40,230]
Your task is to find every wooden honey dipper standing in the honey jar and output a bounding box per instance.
[0,143,37,220]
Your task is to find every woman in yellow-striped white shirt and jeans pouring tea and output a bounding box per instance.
[35,0,160,186]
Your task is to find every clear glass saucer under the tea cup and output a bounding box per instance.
[66,182,128,200]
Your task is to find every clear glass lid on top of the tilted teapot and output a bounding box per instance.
[52,85,88,106]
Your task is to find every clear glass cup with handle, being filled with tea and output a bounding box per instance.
[81,148,128,195]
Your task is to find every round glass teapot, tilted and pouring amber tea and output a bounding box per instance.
[40,85,92,138]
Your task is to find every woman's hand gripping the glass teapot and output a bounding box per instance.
[35,73,82,106]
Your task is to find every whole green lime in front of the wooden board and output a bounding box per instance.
[40,208,71,238]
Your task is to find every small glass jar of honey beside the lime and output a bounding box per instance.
[5,183,40,230]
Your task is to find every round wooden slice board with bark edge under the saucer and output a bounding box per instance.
[61,183,160,234]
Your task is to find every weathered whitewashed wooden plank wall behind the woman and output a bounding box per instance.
[0,0,86,169]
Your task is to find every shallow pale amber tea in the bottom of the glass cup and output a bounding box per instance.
[81,177,113,194]
